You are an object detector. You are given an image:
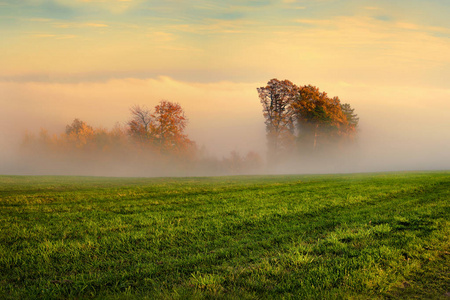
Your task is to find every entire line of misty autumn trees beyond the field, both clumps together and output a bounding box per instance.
[21,79,359,176]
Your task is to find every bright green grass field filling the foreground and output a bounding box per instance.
[0,172,450,299]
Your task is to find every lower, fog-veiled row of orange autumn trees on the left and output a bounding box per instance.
[21,100,264,176]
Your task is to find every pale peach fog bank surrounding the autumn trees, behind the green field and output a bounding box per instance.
[0,77,450,176]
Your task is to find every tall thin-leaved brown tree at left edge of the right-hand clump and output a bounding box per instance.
[257,78,298,164]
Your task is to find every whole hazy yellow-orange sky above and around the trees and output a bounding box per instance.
[0,0,450,172]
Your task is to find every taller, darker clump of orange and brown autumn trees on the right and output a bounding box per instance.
[257,79,359,165]
